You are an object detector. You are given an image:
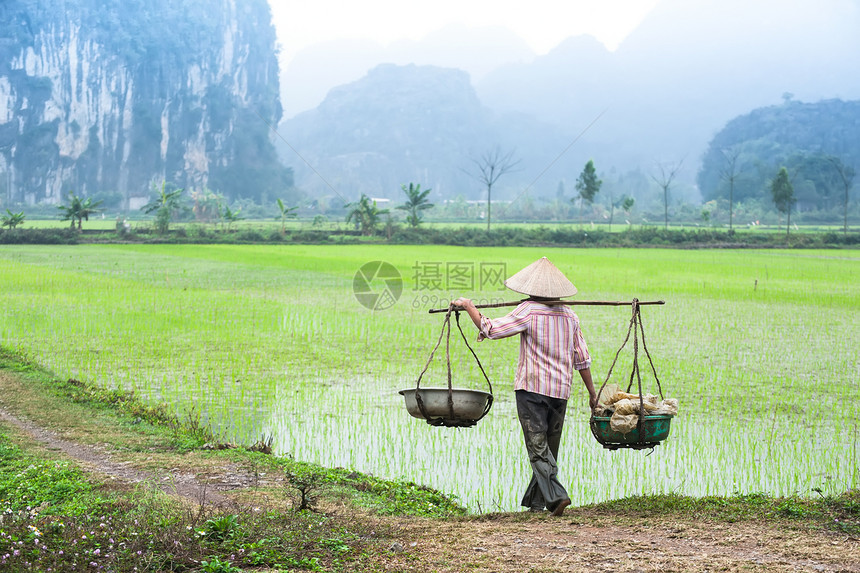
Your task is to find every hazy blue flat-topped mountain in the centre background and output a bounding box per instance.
[280,64,584,201]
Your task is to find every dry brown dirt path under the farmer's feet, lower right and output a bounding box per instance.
[380,513,860,573]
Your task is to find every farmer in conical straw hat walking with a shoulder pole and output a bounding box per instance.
[453,257,597,516]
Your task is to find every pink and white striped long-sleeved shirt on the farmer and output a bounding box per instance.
[478,301,591,400]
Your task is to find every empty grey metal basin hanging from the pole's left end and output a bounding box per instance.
[400,387,493,426]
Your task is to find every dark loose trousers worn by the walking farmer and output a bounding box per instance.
[516,390,569,510]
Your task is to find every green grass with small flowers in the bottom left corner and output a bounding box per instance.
[0,426,398,571]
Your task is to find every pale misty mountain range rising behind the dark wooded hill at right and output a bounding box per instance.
[476,0,860,180]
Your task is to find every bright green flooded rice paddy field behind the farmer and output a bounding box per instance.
[0,245,860,511]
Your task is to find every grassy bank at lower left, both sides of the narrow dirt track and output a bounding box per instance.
[0,349,465,572]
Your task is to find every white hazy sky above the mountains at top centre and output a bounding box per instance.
[270,0,658,63]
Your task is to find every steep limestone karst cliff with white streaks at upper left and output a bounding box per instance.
[0,0,291,209]
